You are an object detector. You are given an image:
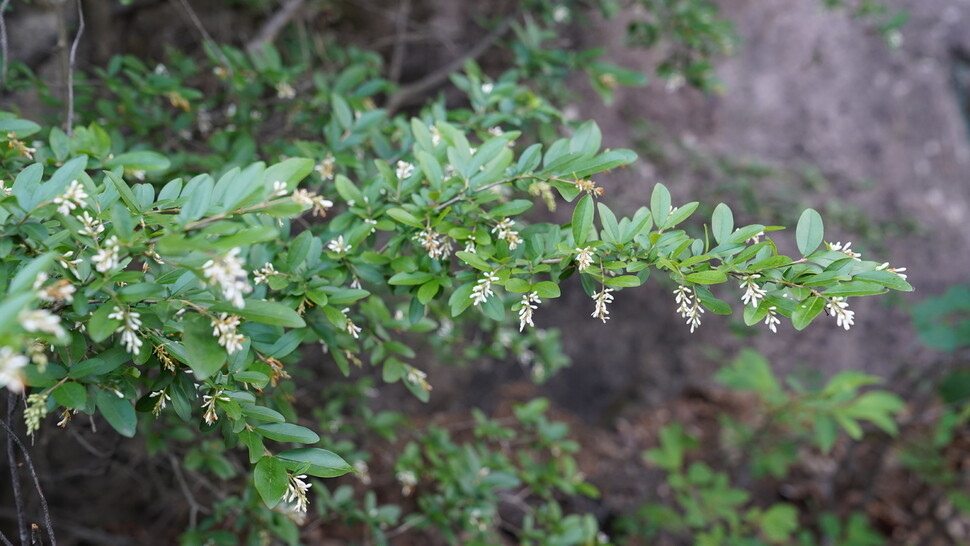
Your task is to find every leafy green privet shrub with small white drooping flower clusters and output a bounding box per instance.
[0,2,912,544]
